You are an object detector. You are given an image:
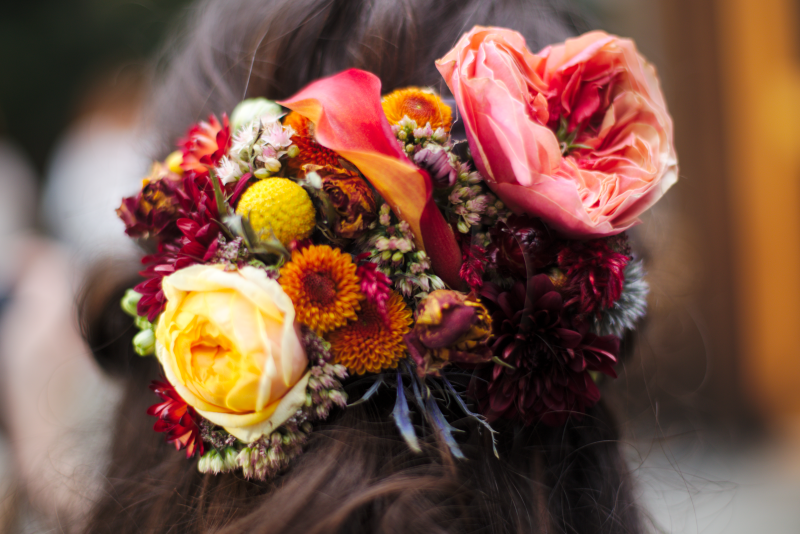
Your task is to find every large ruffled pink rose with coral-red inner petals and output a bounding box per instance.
[436,27,678,238]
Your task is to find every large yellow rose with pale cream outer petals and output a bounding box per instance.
[156,265,309,443]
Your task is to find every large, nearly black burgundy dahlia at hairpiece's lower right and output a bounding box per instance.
[470,274,619,425]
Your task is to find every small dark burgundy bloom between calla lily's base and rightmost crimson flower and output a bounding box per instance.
[488,215,559,278]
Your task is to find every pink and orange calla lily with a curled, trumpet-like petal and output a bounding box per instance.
[278,69,462,288]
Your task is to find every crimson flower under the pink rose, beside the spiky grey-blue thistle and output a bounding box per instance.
[558,236,630,316]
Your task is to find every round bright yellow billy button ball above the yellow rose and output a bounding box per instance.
[236,178,316,247]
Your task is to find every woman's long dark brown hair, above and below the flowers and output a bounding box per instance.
[83,0,642,534]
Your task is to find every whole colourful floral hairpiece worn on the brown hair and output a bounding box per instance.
[117,27,677,479]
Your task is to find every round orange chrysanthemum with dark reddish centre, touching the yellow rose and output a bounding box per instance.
[278,245,364,334]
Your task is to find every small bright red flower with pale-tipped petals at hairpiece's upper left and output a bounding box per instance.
[178,114,231,176]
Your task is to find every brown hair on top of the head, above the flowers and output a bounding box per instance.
[152,0,584,155]
